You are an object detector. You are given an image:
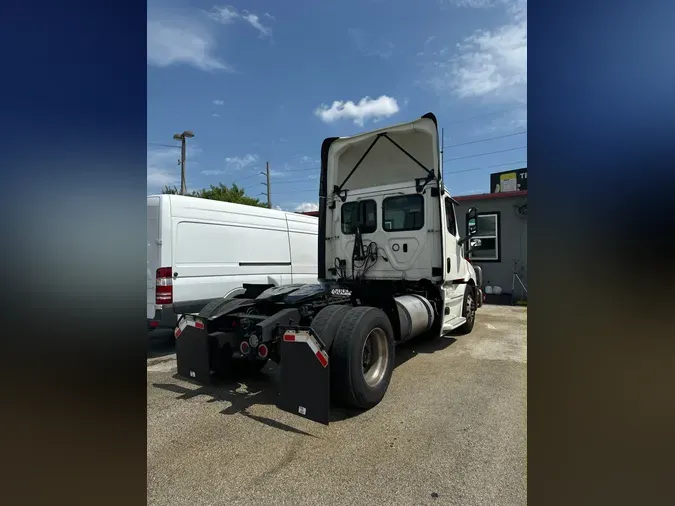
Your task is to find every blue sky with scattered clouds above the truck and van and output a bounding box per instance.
[147,0,527,211]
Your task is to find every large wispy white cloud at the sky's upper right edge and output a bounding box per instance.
[430,0,527,104]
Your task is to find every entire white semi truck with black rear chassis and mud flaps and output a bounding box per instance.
[174,113,483,424]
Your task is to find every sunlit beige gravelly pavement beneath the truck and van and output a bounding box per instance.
[147,306,527,506]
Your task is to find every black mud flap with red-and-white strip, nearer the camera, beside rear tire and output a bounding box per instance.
[277,327,330,425]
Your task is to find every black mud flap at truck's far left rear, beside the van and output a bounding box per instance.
[174,315,211,384]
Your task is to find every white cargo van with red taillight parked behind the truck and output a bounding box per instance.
[147,195,318,329]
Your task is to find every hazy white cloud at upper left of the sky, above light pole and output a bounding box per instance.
[147,11,233,72]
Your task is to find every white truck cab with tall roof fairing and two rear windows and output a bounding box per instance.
[319,114,482,334]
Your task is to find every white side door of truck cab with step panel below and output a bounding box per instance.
[443,193,466,323]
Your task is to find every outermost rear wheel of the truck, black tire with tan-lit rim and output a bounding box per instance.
[330,306,394,409]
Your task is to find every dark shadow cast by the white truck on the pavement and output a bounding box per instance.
[153,337,456,437]
